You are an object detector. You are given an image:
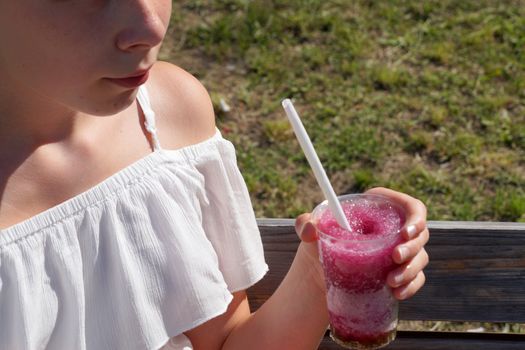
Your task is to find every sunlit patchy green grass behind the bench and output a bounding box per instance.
[162,0,525,221]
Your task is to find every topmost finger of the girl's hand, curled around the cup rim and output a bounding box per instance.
[366,187,427,240]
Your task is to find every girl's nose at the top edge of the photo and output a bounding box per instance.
[116,0,169,52]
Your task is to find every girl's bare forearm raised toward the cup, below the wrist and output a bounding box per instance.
[223,243,328,350]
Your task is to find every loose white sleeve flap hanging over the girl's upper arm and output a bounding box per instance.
[190,139,268,292]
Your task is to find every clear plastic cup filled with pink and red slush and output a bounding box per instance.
[313,194,405,349]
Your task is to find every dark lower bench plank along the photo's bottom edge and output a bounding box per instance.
[318,331,525,350]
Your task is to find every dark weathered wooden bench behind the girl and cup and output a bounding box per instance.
[248,219,525,350]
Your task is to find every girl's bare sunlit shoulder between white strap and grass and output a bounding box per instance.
[147,62,215,149]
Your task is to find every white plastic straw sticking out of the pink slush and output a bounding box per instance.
[282,99,351,231]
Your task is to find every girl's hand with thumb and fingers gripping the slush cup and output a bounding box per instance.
[295,187,429,300]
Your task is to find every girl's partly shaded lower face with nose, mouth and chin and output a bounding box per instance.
[0,0,172,115]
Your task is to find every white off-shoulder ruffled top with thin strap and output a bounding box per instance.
[0,87,268,350]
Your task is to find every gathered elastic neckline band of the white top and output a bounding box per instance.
[0,128,223,249]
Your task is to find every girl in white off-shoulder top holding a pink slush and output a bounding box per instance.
[0,0,428,350]
